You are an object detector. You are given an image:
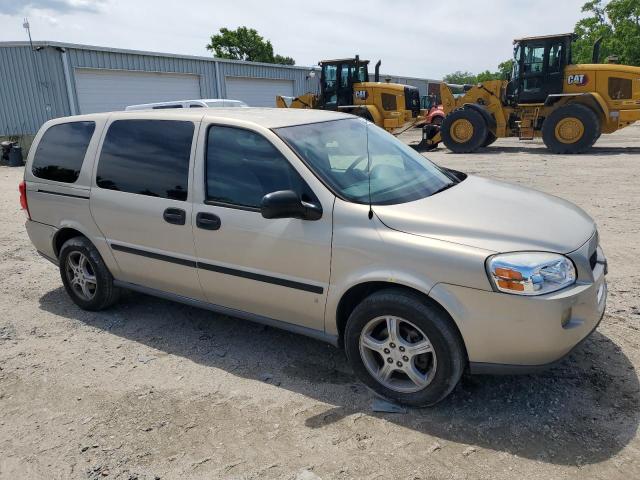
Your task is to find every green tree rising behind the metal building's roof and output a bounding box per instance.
[207,27,296,65]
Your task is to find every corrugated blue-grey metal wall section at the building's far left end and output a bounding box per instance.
[0,46,69,135]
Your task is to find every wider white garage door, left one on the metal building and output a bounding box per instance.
[75,69,200,113]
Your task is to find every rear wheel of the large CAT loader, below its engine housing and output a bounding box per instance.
[542,103,601,154]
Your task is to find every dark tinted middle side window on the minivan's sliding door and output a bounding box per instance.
[96,120,194,200]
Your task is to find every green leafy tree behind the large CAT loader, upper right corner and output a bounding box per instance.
[573,0,640,65]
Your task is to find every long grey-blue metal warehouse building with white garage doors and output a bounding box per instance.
[0,42,437,136]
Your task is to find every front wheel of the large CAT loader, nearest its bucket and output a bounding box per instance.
[440,108,489,153]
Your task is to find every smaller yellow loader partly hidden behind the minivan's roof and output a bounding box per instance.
[276,55,420,135]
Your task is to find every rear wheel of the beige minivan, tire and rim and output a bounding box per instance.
[58,237,120,311]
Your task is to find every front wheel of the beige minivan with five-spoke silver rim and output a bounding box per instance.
[344,289,466,407]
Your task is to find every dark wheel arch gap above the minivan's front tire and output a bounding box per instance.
[336,281,467,355]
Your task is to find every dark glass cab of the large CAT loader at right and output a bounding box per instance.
[507,33,574,104]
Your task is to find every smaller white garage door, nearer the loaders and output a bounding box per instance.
[225,77,293,107]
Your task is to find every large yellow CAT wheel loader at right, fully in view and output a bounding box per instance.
[421,33,640,154]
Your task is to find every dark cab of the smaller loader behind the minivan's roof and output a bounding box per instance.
[319,55,369,110]
